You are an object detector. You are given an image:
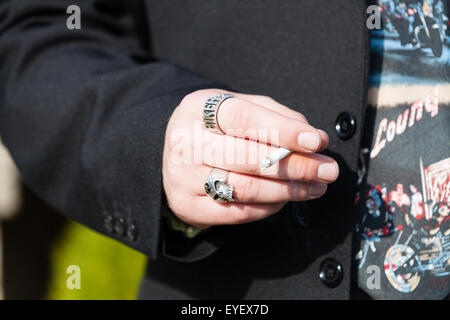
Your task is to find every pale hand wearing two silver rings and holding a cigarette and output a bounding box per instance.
[162,89,339,228]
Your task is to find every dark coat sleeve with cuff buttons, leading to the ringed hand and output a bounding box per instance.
[0,0,225,258]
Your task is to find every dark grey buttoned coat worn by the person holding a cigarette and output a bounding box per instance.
[0,0,369,299]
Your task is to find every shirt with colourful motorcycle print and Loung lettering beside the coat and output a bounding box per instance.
[354,0,450,299]
